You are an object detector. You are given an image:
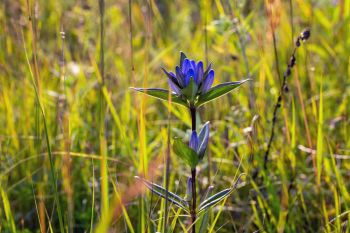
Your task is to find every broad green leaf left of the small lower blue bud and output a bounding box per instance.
[173,138,198,169]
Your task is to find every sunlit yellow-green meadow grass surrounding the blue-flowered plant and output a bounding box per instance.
[0,0,350,232]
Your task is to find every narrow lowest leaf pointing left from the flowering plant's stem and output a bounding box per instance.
[135,176,189,212]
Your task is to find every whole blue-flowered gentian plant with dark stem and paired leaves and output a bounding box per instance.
[133,52,247,233]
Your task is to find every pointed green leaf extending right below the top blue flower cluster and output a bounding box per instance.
[196,79,249,107]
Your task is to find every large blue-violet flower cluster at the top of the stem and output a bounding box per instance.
[162,52,214,100]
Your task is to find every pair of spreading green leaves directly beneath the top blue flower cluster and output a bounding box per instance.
[131,79,249,107]
